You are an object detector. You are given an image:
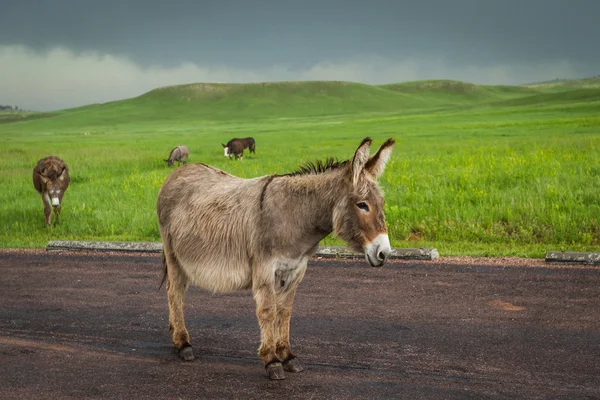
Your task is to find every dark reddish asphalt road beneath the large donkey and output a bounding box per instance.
[0,250,600,399]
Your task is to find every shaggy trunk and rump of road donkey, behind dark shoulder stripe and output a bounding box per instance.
[157,164,264,292]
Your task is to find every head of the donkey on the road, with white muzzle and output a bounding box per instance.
[333,138,394,267]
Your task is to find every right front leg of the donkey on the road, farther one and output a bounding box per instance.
[276,286,304,372]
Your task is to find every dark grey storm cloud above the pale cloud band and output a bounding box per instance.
[0,0,600,67]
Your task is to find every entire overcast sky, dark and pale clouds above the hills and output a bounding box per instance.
[0,0,600,110]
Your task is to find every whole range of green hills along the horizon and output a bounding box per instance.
[0,78,600,130]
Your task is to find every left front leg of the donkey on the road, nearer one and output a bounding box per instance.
[252,279,285,379]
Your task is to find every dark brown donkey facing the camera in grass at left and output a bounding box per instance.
[33,156,70,226]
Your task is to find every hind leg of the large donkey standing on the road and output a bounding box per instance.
[163,246,194,361]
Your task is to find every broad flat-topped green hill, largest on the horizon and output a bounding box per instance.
[45,82,440,126]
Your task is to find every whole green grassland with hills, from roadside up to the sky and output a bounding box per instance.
[0,79,600,257]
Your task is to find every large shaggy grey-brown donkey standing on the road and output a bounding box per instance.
[157,138,394,379]
